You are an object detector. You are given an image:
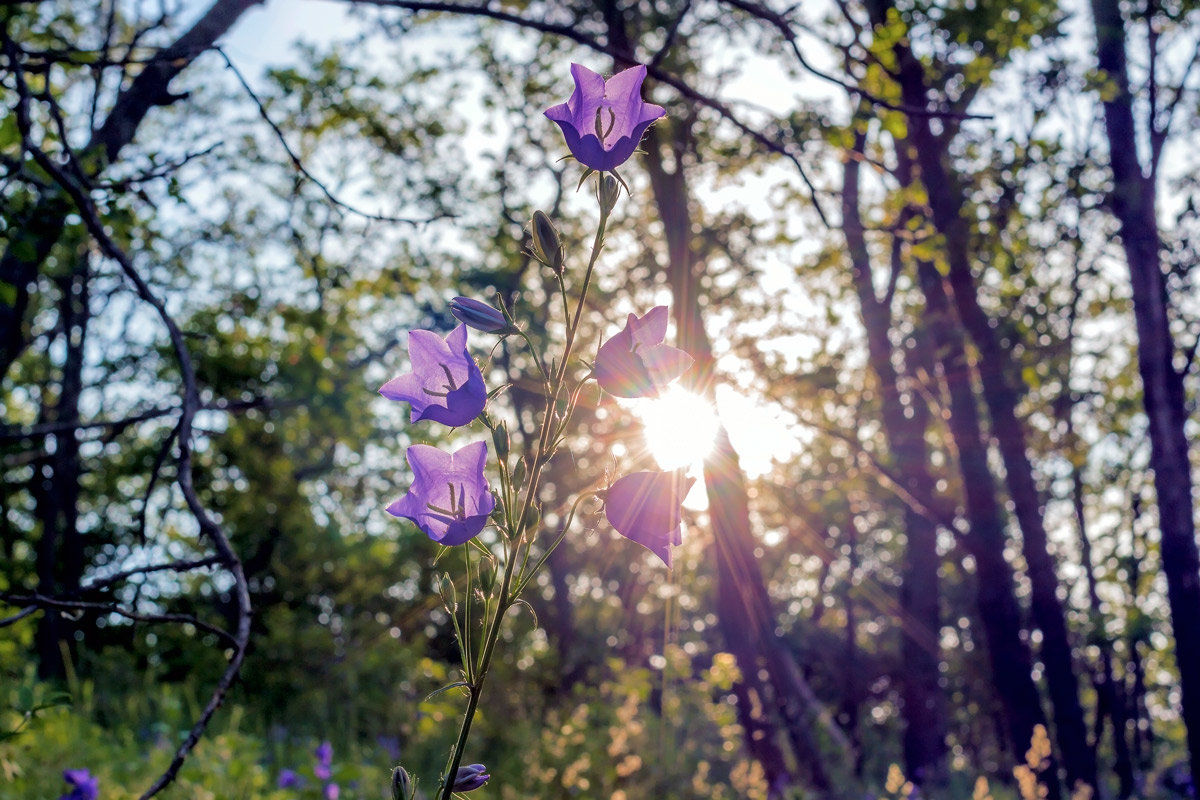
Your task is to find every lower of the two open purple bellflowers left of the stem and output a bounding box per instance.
[388,441,496,546]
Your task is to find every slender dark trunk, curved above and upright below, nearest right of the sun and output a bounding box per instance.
[841,134,947,786]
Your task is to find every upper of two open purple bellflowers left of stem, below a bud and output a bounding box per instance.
[379,325,487,427]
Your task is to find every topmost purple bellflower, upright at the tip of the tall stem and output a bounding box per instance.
[546,64,666,172]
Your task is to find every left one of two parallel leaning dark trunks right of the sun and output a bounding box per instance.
[917,261,1060,798]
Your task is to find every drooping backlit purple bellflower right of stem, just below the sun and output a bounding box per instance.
[604,471,696,566]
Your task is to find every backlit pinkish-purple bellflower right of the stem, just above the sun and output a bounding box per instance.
[595,306,692,397]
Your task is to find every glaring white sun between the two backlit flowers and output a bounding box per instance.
[637,386,719,469]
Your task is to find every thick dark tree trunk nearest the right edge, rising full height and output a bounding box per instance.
[1092,0,1200,776]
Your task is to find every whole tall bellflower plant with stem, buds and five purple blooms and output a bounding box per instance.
[379,64,692,800]
